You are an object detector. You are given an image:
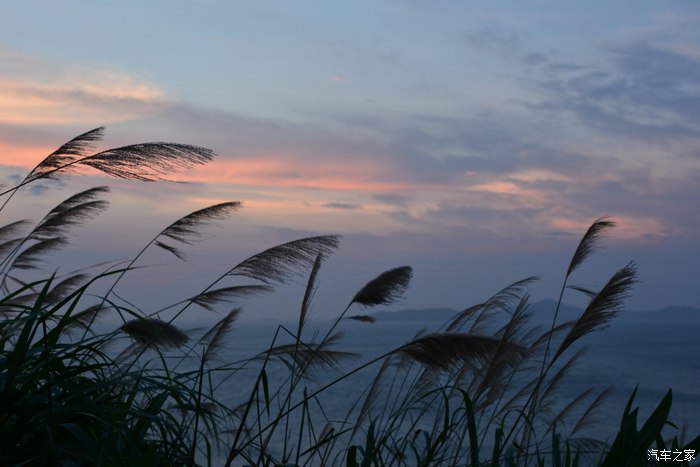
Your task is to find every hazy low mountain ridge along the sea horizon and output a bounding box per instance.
[372,299,700,322]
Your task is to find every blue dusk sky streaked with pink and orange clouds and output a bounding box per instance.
[0,0,700,319]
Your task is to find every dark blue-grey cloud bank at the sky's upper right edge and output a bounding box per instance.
[532,41,700,144]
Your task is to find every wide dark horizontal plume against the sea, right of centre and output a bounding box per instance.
[397,332,525,370]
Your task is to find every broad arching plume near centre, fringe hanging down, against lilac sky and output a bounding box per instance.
[228,235,340,284]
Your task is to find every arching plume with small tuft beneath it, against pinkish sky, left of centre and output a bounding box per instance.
[154,201,242,259]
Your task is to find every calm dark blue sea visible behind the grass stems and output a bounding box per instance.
[193,315,700,464]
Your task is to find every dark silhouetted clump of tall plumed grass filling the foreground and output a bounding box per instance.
[0,128,700,466]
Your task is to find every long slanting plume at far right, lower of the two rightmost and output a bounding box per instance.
[552,262,637,362]
